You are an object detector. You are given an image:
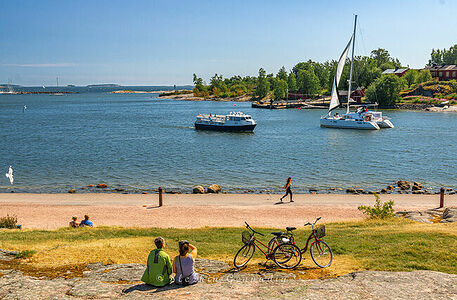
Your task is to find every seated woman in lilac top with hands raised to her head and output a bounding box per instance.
[173,241,198,285]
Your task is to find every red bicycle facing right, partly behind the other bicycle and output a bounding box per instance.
[269,217,333,268]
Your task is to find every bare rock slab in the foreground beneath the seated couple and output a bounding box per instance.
[0,251,457,299]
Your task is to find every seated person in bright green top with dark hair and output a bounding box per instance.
[141,236,173,287]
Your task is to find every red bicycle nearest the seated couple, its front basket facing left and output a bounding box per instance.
[233,222,302,269]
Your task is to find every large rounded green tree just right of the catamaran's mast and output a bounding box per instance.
[366,74,407,108]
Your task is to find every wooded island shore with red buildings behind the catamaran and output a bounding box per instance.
[160,44,457,109]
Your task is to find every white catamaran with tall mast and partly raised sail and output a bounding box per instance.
[320,15,394,130]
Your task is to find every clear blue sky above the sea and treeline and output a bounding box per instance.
[0,0,457,86]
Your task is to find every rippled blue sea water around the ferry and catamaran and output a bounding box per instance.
[0,93,457,191]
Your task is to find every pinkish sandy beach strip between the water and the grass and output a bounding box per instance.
[0,193,457,229]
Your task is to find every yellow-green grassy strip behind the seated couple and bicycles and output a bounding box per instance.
[0,219,457,275]
